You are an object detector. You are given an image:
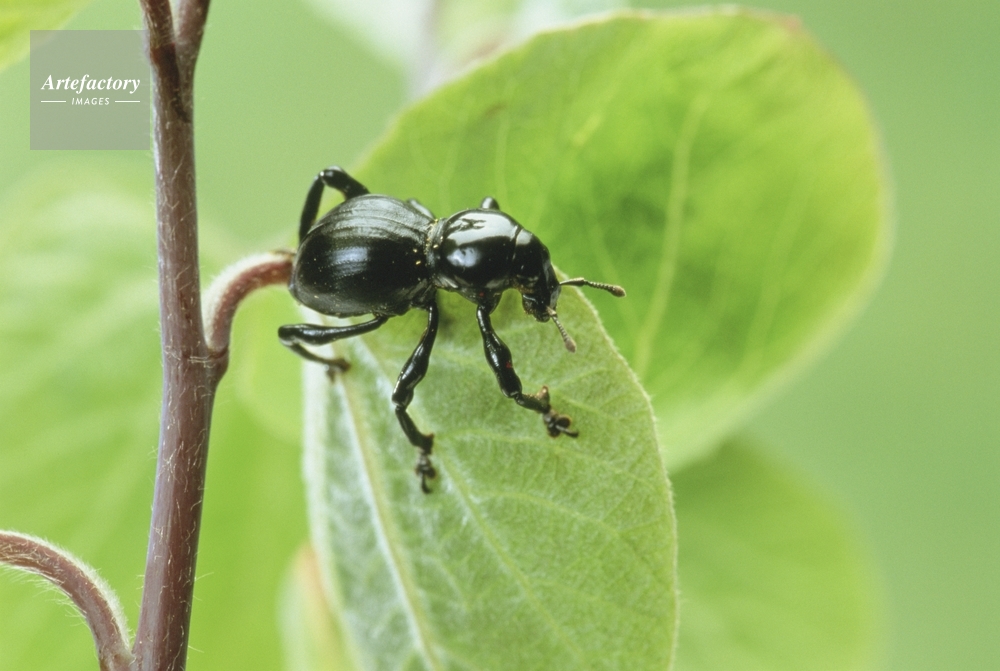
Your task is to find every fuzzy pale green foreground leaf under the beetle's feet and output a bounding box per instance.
[306,289,676,669]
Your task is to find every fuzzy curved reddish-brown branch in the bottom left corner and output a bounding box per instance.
[0,531,132,671]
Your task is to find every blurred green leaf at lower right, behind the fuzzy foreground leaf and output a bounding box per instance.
[673,443,878,671]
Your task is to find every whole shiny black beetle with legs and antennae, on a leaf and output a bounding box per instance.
[278,166,625,492]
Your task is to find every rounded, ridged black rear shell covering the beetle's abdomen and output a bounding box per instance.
[289,194,435,317]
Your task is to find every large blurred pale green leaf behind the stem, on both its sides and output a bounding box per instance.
[0,164,307,671]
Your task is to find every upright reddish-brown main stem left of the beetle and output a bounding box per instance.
[133,0,217,671]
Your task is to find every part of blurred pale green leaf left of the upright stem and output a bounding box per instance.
[0,163,160,671]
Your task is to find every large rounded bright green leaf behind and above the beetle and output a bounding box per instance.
[359,9,889,465]
